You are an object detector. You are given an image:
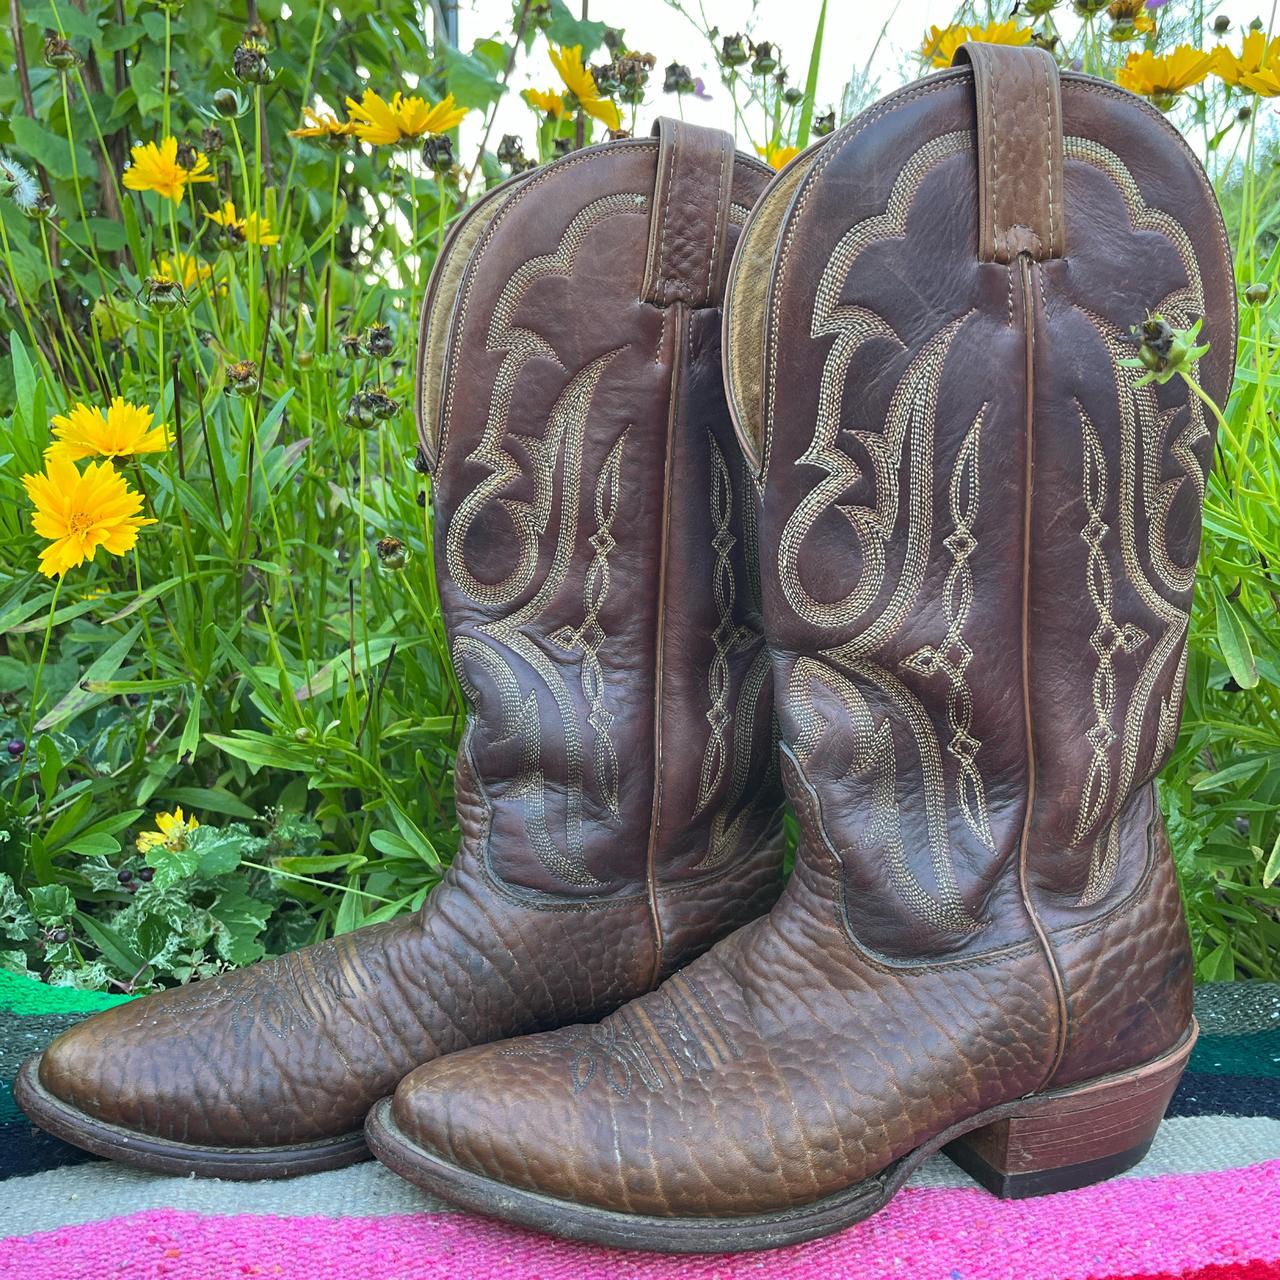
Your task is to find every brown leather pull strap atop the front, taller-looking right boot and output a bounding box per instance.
[952,44,1066,262]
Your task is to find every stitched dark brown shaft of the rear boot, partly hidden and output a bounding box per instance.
[419,122,778,901]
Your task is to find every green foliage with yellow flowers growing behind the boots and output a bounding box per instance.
[0,0,1280,989]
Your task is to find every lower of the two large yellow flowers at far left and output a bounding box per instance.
[22,457,155,577]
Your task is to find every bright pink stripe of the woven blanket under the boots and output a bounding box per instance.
[10,1160,1280,1280]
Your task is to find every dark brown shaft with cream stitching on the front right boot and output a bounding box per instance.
[727,51,1235,960]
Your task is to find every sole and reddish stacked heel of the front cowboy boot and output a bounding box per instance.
[365,1019,1198,1253]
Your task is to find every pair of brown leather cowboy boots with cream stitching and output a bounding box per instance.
[19,46,1235,1252]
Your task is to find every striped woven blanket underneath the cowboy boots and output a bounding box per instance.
[0,972,1280,1280]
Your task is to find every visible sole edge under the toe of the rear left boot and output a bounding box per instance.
[13,1055,369,1181]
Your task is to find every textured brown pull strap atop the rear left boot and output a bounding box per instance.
[644,118,733,307]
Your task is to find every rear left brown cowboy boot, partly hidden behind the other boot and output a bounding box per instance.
[17,122,782,1178]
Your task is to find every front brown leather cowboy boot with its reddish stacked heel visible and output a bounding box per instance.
[366,45,1235,1251]
